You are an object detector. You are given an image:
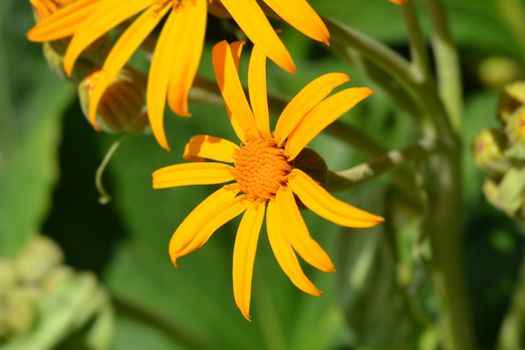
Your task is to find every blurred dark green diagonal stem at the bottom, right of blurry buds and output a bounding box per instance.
[111,296,209,350]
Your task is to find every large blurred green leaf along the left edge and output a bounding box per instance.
[0,0,73,255]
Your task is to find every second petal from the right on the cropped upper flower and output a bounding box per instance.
[221,0,295,73]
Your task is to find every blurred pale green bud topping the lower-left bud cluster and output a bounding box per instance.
[15,236,64,283]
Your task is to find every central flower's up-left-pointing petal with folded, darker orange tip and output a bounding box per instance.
[212,41,257,141]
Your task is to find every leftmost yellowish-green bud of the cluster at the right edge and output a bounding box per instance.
[472,129,510,178]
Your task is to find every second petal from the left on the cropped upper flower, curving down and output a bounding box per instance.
[64,0,153,75]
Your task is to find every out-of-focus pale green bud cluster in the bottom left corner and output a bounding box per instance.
[0,236,109,349]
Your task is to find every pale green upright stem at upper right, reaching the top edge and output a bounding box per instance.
[425,0,460,133]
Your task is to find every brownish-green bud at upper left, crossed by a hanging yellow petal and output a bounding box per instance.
[78,67,148,133]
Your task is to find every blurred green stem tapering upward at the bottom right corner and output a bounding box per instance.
[497,247,525,350]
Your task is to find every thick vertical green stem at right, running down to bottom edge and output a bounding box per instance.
[423,153,475,350]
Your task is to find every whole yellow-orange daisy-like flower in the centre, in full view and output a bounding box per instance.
[153,41,383,319]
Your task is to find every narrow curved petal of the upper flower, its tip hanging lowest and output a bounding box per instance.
[146,11,180,150]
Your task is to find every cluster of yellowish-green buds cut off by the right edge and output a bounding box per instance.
[472,82,525,219]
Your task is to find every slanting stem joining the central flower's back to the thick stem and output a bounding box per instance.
[327,139,439,192]
